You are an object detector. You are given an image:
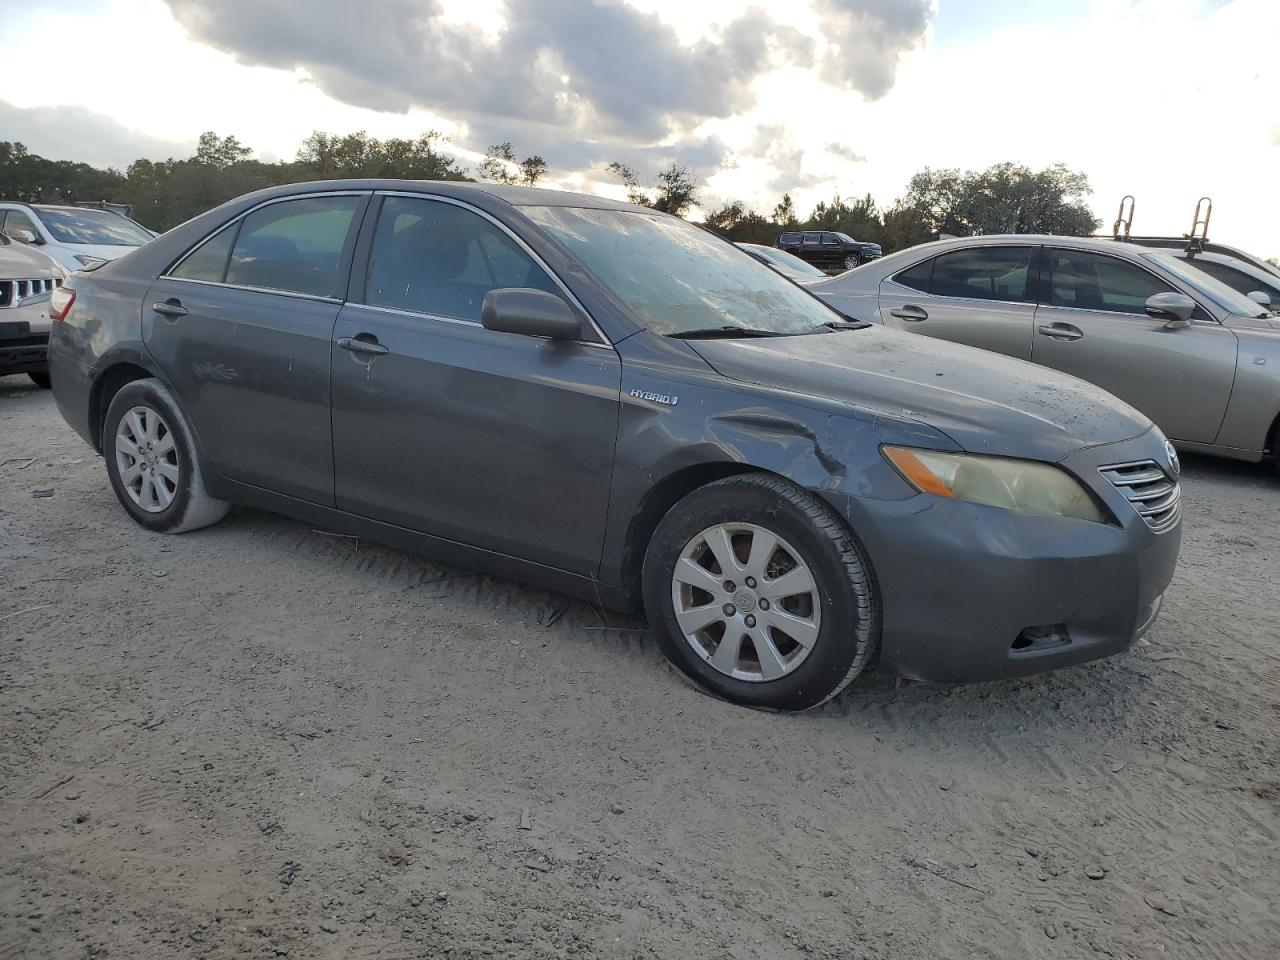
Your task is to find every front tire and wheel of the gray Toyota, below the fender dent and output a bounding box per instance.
[641,474,881,710]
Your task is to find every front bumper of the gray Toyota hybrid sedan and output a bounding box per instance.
[828,430,1181,681]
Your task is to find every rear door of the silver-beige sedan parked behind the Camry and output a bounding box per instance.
[879,243,1039,360]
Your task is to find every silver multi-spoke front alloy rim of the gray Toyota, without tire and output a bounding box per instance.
[671,524,822,682]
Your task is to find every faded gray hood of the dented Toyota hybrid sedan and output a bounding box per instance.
[689,326,1151,461]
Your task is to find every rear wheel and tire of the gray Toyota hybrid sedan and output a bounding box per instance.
[102,379,230,534]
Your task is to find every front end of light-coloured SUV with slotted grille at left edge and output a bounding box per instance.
[0,236,63,389]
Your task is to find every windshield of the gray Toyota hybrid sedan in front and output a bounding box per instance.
[524,206,840,334]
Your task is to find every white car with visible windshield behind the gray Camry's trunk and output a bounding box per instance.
[0,202,155,273]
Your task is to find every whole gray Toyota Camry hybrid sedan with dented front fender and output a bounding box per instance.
[50,180,1180,709]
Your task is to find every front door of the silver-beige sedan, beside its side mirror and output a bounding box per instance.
[1032,247,1236,443]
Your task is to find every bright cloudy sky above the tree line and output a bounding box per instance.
[0,0,1280,256]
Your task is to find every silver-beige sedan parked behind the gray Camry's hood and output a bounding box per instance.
[809,234,1280,473]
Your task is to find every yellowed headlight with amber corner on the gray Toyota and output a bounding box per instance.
[883,447,1106,524]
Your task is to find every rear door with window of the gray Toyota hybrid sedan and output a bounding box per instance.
[142,193,369,506]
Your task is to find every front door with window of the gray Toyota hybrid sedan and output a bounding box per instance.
[333,196,621,576]
